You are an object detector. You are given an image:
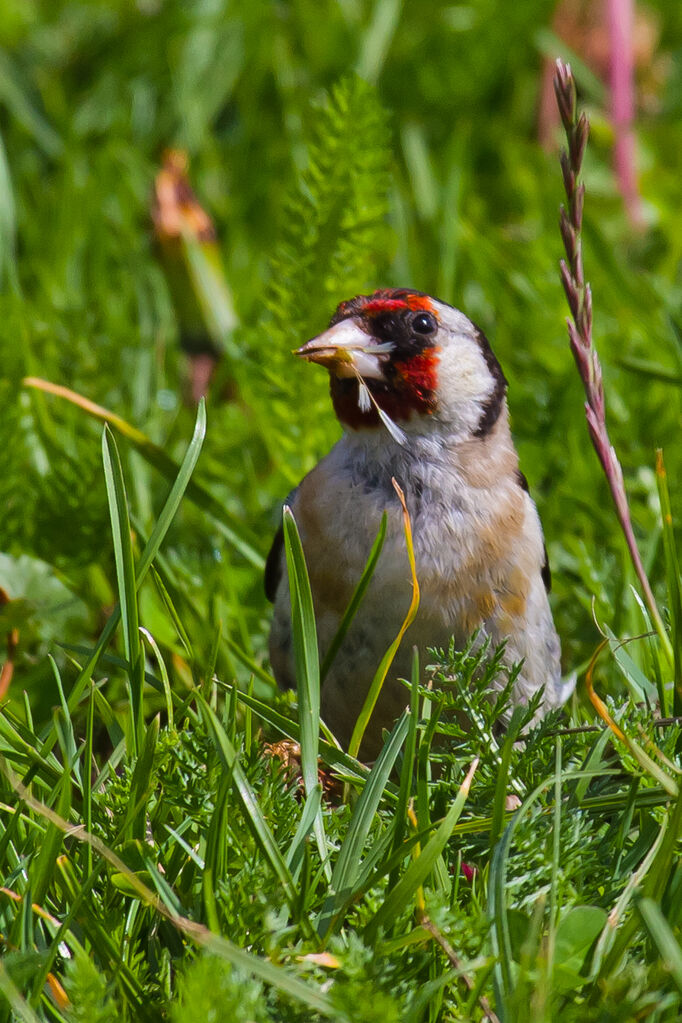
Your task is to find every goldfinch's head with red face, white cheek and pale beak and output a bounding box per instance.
[297,288,507,438]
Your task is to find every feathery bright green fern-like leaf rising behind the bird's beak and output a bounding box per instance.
[241,77,390,482]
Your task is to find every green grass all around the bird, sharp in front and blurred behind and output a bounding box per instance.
[0,0,682,1023]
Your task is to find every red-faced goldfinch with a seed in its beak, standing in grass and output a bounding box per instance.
[265,288,573,757]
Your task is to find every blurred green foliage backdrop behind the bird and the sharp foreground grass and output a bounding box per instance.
[0,0,682,1019]
